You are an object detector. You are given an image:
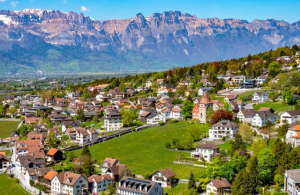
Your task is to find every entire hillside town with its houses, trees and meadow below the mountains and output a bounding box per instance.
[0,45,300,195]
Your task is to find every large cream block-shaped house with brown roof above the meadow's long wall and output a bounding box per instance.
[104,112,123,131]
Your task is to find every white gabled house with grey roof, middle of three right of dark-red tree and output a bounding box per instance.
[251,111,278,127]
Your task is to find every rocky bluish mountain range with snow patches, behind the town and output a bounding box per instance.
[0,9,300,74]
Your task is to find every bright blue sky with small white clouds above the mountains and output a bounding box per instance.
[0,0,300,23]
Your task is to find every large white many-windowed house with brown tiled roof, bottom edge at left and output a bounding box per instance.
[51,172,89,195]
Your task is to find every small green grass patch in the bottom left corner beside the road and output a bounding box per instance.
[0,173,30,195]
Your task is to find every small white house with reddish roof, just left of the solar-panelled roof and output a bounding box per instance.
[88,174,113,194]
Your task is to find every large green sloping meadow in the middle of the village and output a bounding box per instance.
[75,122,209,179]
